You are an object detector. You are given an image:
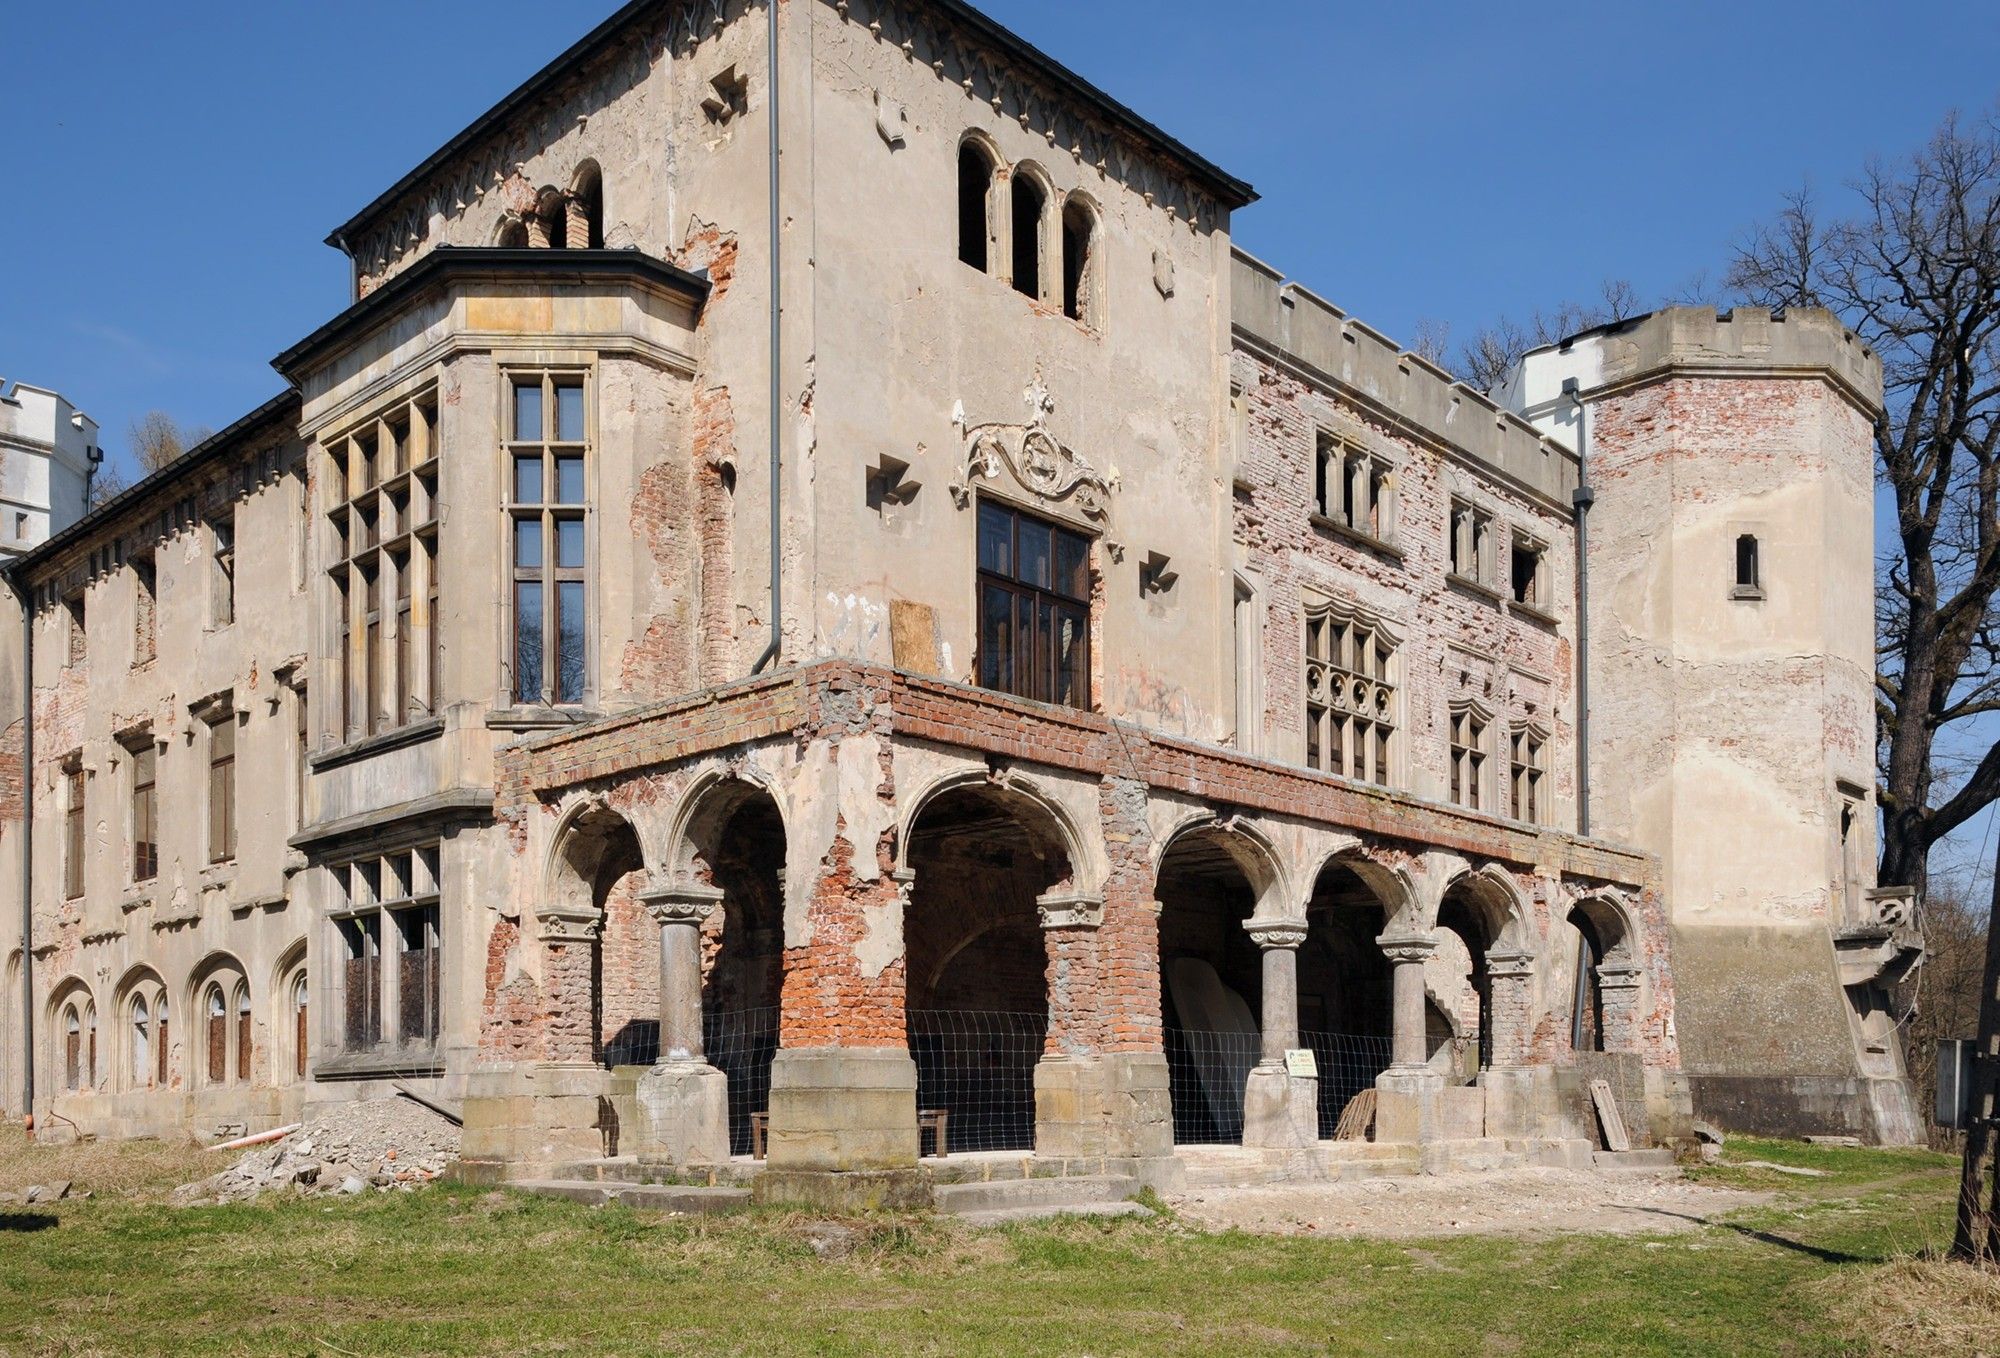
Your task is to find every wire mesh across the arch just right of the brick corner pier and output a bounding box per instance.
[908,1010,1048,1154]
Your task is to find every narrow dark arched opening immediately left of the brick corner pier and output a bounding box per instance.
[688,780,784,1156]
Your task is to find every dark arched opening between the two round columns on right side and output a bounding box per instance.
[1298,858,1400,1138]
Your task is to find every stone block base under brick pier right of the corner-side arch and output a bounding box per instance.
[1034,1052,1174,1160]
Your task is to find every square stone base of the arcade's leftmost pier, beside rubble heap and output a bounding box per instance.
[458,1064,638,1182]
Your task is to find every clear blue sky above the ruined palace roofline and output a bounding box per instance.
[0,0,2000,872]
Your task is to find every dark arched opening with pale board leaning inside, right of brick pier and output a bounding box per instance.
[1154,824,1264,1146]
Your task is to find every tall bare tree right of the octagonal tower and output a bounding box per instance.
[1728,114,2000,904]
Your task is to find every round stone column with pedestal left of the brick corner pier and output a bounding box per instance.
[636,882,730,1166]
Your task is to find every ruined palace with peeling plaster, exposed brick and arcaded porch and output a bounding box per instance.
[0,0,1920,1200]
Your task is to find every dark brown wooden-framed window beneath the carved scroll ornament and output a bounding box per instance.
[978,500,1090,708]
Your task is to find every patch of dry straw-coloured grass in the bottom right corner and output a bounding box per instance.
[1816,1258,2000,1358]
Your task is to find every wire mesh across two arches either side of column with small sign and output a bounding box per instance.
[1166,1028,1390,1146]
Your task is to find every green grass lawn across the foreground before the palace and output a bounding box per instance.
[0,1140,1976,1358]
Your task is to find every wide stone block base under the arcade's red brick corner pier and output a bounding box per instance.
[766,1046,916,1190]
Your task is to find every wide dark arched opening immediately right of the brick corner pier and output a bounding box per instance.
[902,784,1072,1152]
